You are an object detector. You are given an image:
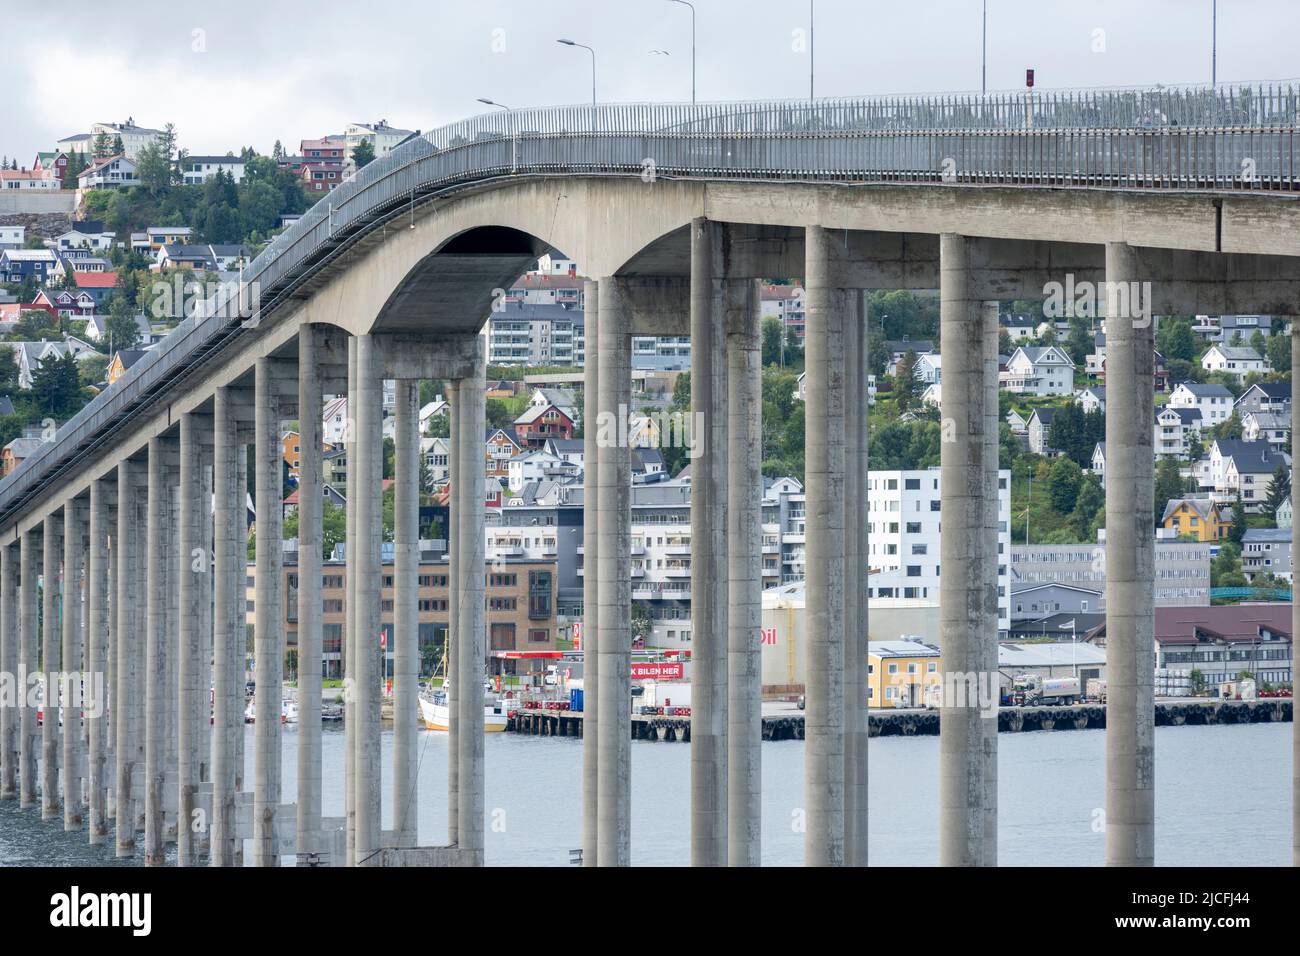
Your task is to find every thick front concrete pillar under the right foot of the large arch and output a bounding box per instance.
[588,277,631,866]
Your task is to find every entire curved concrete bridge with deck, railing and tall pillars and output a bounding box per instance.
[0,87,1300,865]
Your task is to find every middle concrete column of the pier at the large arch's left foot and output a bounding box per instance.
[393,378,420,847]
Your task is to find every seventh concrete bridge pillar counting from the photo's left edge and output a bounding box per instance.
[144,437,174,866]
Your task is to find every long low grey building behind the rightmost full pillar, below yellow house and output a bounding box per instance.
[1010,540,1210,610]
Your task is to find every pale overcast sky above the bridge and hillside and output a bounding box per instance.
[0,0,1300,165]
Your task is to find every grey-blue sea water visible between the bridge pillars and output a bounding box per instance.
[0,723,1292,866]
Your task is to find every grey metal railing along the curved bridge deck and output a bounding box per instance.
[0,82,1300,524]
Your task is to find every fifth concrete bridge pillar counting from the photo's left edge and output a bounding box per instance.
[86,480,111,844]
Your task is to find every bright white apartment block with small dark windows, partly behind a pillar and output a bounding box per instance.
[867,468,1011,632]
